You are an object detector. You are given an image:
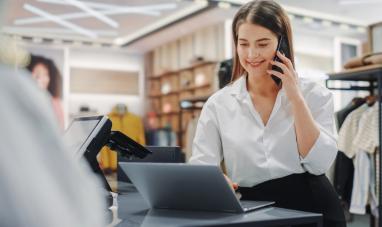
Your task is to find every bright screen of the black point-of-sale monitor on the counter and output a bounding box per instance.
[64,117,103,157]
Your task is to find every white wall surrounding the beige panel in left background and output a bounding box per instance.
[68,49,144,119]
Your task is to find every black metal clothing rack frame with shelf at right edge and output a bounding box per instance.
[326,65,382,227]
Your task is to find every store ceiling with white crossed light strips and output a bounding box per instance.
[3,0,382,51]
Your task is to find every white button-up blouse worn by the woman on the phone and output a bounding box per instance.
[189,76,337,187]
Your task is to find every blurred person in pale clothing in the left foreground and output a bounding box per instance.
[0,0,106,227]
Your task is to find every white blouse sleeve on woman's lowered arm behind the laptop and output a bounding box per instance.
[189,100,222,165]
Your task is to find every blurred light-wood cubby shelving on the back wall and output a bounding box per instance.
[148,61,217,145]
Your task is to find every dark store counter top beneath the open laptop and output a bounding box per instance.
[113,187,322,227]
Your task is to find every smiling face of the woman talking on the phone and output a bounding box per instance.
[237,22,278,76]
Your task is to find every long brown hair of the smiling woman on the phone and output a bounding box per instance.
[231,0,294,82]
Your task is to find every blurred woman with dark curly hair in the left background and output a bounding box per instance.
[27,55,64,129]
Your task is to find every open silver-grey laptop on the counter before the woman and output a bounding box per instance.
[119,162,274,213]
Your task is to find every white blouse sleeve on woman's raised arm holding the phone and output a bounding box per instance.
[301,87,338,175]
